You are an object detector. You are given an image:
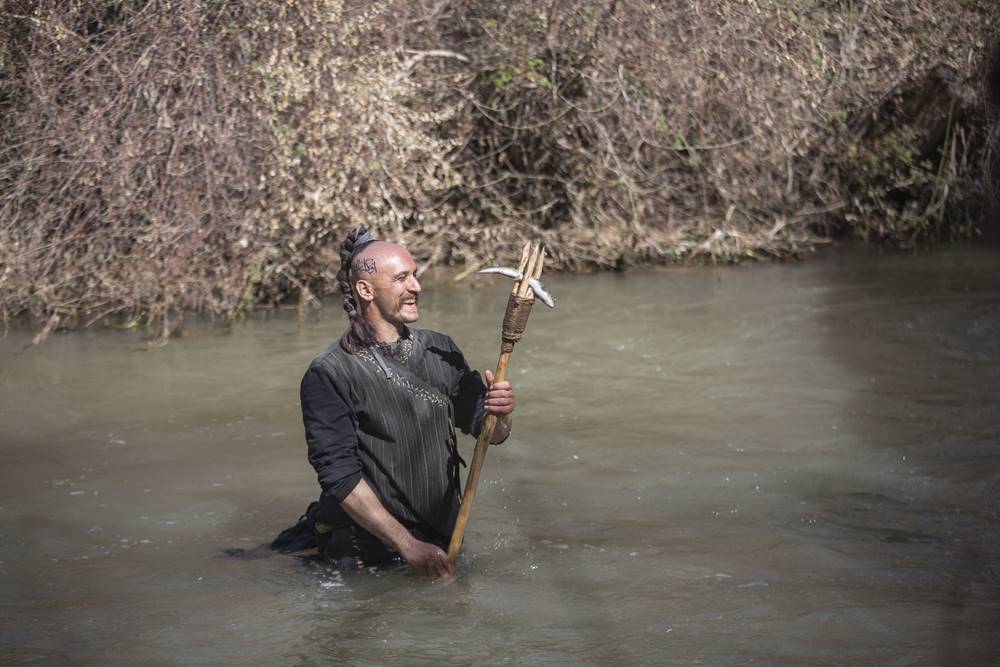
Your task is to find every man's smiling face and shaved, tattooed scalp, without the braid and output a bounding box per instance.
[355,243,420,326]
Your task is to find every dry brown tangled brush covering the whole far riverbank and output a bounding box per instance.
[0,0,1000,337]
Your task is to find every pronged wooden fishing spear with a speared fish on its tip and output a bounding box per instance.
[448,242,556,563]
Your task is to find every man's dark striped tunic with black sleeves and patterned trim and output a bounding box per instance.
[301,329,486,543]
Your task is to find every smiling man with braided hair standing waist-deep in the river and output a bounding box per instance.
[290,227,514,577]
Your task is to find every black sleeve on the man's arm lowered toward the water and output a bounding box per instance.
[299,364,361,503]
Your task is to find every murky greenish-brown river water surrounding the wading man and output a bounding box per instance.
[0,247,1000,665]
